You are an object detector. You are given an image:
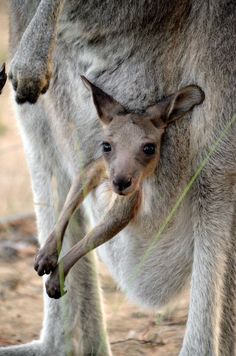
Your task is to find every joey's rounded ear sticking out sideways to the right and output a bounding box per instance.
[147,85,205,127]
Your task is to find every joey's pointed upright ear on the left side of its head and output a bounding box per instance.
[81,76,126,125]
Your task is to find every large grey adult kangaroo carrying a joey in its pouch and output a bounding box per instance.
[0,0,236,356]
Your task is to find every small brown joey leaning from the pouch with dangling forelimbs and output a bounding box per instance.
[35,77,204,298]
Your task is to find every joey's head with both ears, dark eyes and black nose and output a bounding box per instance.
[81,77,204,195]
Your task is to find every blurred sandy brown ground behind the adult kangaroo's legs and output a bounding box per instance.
[0,0,187,356]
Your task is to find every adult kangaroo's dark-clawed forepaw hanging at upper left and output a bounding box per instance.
[9,54,51,104]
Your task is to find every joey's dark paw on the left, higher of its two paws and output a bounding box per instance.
[34,245,58,276]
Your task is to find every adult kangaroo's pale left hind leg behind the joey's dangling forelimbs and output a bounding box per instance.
[0,103,110,356]
